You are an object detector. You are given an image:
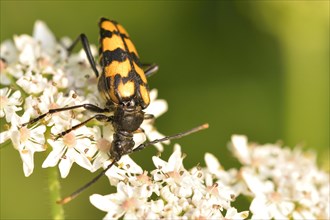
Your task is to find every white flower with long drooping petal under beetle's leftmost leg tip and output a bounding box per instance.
[0,112,46,176]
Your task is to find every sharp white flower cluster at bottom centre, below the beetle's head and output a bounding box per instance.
[90,145,249,219]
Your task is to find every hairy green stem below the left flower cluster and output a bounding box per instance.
[47,167,64,220]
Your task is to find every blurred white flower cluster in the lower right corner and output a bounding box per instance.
[230,135,330,219]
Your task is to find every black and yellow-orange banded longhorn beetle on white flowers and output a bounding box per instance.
[23,18,208,204]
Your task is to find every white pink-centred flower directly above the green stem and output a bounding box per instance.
[42,120,96,178]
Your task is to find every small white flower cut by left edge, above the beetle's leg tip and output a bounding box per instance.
[0,88,22,122]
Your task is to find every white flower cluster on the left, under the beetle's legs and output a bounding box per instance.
[0,21,167,178]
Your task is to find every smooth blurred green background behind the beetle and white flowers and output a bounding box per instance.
[0,0,329,219]
